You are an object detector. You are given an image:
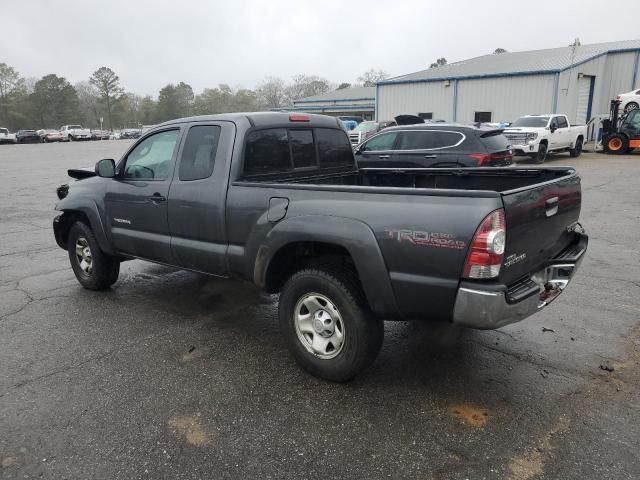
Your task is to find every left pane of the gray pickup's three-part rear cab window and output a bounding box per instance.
[244,128,291,175]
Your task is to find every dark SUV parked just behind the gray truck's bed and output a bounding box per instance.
[355,123,513,168]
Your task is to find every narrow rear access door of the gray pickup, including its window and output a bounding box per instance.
[168,122,235,275]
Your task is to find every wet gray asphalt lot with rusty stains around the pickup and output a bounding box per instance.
[0,141,640,480]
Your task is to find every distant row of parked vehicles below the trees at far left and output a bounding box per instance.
[0,125,142,144]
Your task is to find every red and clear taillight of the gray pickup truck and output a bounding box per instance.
[462,209,506,279]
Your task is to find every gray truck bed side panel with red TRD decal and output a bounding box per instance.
[227,182,502,320]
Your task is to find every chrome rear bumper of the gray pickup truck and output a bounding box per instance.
[453,233,589,330]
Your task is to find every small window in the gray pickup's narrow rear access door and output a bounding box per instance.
[179,125,220,181]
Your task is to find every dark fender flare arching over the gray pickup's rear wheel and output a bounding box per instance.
[253,215,400,318]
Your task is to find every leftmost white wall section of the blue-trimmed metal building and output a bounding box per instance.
[376,81,453,120]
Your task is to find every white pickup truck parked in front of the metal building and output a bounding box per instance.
[503,113,587,163]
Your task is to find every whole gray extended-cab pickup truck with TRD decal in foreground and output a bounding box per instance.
[53,113,588,381]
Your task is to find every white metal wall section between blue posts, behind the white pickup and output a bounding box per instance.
[458,74,554,122]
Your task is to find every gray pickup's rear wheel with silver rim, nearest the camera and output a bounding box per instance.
[279,268,384,382]
